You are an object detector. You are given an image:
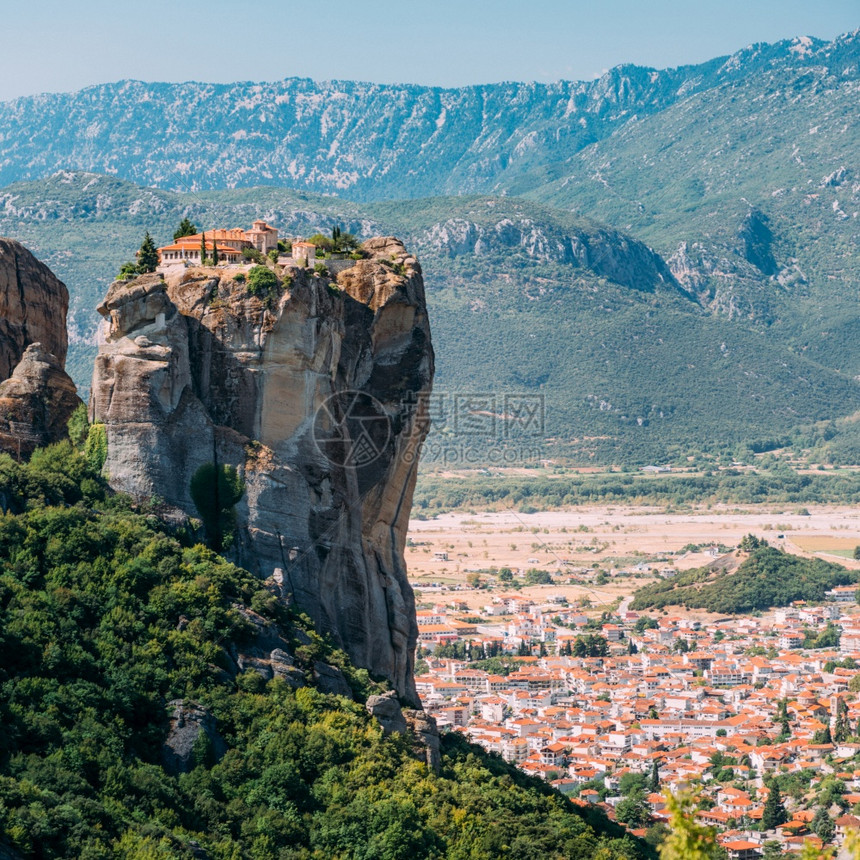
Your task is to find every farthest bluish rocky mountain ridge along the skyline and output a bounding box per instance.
[0,32,860,200]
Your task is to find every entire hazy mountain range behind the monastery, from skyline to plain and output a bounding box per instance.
[0,32,860,462]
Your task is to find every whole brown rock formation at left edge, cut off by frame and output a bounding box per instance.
[0,239,80,458]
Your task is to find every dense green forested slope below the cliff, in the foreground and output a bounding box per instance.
[0,446,648,860]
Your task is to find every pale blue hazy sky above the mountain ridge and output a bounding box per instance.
[0,0,860,101]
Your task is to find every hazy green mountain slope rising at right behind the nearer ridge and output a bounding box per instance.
[529,34,860,375]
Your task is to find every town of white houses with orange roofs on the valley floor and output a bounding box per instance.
[416,586,860,858]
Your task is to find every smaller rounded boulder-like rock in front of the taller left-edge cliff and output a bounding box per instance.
[0,343,81,459]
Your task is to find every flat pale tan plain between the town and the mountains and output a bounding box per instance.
[406,505,860,608]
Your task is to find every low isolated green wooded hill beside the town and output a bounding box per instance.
[631,546,858,616]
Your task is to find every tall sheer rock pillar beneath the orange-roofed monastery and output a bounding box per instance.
[90,239,433,703]
